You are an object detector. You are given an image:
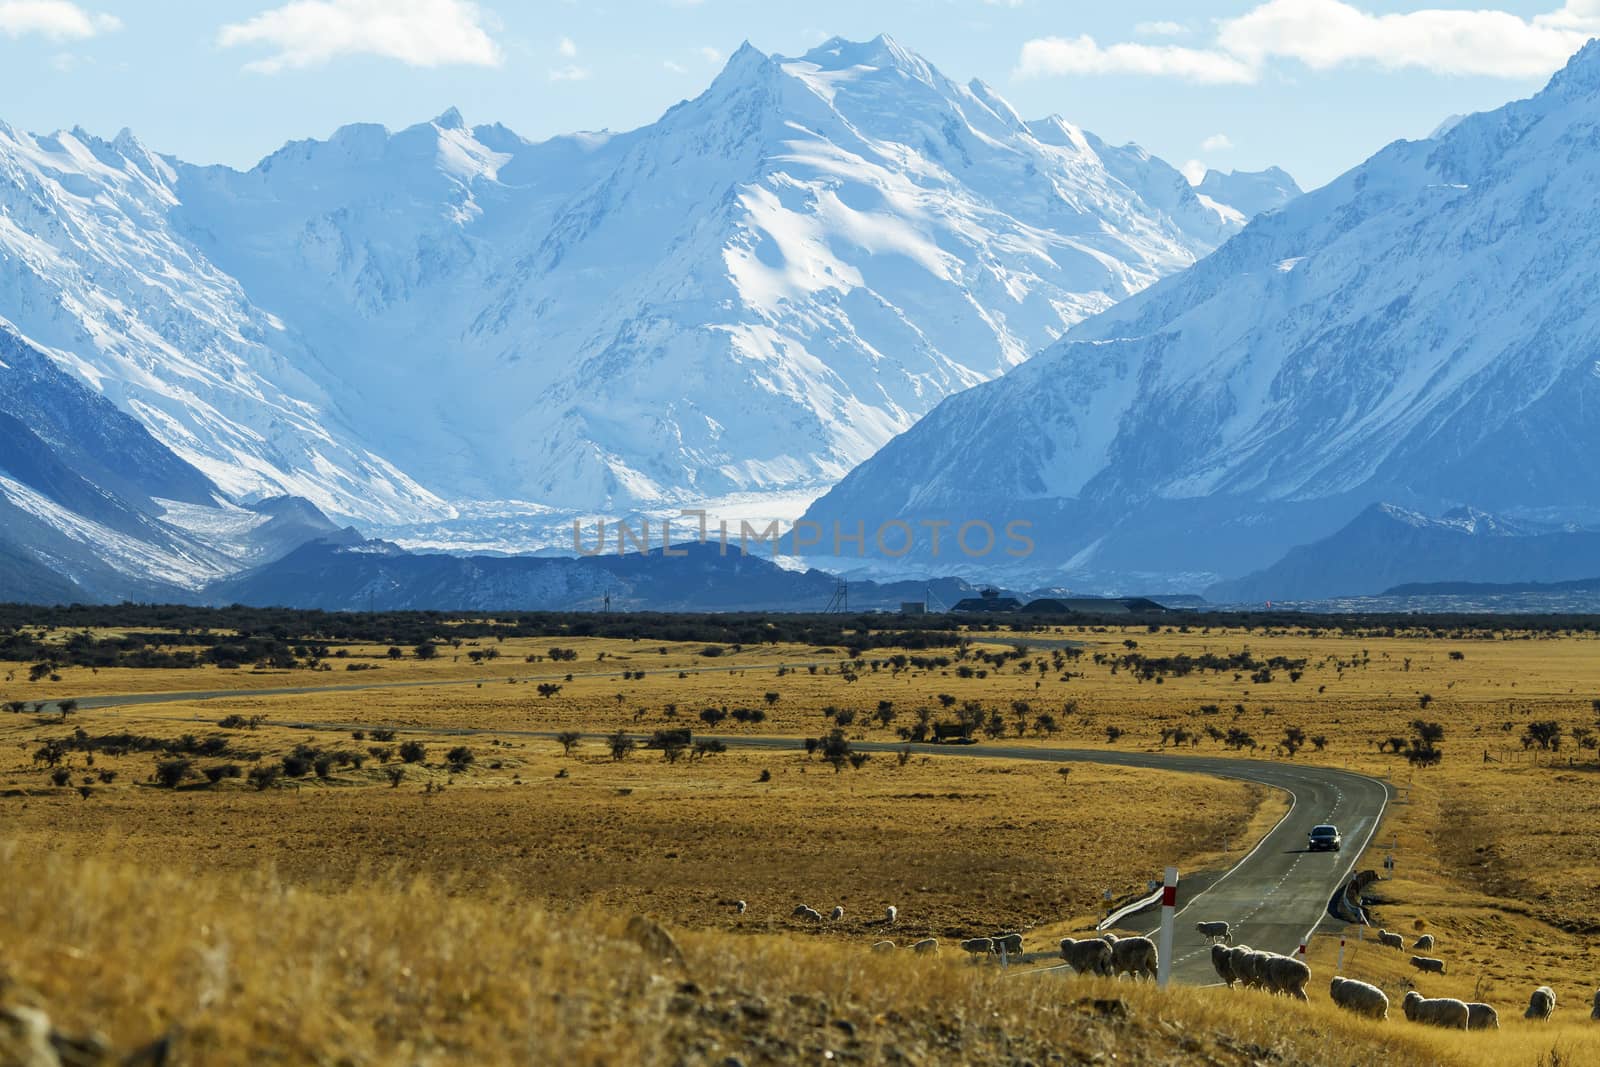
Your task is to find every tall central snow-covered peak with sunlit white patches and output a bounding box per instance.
[174,38,1273,524]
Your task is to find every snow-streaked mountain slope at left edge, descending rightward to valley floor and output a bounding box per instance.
[0,123,448,522]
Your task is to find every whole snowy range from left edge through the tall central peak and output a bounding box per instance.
[0,37,1293,585]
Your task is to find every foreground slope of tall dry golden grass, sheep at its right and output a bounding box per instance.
[0,845,1523,1067]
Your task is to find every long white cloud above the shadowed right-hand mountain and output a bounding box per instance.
[1018,0,1600,85]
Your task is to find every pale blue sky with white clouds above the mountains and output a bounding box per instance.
[0,0,1600,187]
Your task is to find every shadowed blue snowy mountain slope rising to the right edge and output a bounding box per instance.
[810,43,1600,587]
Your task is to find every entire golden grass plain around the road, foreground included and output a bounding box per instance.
[0,627,1600,1067]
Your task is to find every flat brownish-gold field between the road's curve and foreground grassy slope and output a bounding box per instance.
[0,723,1283,939]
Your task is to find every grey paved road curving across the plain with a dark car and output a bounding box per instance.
[50,684,1389,984]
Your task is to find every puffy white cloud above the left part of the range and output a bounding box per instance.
[218,0,501,74]
